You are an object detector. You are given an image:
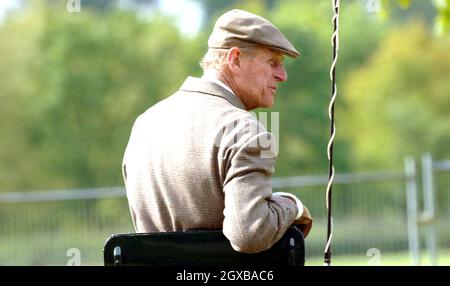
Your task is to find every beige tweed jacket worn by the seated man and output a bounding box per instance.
[123,77,297,253]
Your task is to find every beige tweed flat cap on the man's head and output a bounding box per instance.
[208,9,300,58]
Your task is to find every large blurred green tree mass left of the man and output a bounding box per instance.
[0,1,201,190]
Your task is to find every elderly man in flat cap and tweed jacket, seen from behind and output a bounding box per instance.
[123,10,312,253]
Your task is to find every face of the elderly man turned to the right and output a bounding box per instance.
[236,48,287,110]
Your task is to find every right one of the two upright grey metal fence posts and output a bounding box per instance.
[420,153,437,266]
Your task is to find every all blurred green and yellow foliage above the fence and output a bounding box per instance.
[0,0,450,191]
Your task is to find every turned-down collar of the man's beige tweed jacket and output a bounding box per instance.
[180,76,245,110]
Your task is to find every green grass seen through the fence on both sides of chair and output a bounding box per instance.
[0,198,450,266]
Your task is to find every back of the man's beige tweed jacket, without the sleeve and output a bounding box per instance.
[124,77,246,232]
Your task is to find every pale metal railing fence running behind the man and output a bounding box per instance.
[0,155,450,265]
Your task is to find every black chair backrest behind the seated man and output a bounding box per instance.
[103,226,305,267]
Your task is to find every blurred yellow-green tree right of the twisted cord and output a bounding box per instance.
[338,24,450,169]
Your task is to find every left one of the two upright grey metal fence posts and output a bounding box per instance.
[405,157,420,265]
